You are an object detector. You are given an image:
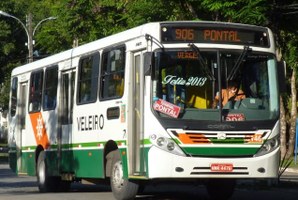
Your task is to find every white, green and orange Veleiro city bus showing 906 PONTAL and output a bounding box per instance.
[8,21,281,200]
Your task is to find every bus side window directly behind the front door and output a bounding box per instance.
[100,46,125,99]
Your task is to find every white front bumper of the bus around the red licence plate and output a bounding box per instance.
[148,147,280,179]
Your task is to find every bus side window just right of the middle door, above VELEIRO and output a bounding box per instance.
[78,52,99,104]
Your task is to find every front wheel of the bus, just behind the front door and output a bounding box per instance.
[110,150,139,200]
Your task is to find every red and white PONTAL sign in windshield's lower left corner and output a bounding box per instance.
[153,99,181,118]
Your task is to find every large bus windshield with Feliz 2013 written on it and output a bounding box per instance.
[152,48,279,121]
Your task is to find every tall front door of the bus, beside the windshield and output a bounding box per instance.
[128,52,145,175]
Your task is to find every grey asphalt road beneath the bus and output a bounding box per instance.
[0,164,298,200]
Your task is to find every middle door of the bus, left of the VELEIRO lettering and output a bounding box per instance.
[57,69,75,173]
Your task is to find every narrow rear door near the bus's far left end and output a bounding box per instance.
[15,82,28,174]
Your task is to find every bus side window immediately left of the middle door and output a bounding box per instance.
[42,66,58,110]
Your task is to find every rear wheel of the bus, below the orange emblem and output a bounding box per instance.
[37,151,55,192]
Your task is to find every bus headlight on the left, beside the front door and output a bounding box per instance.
[150,134,185,156]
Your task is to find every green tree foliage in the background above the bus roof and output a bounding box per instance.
[0,0,298,112]
